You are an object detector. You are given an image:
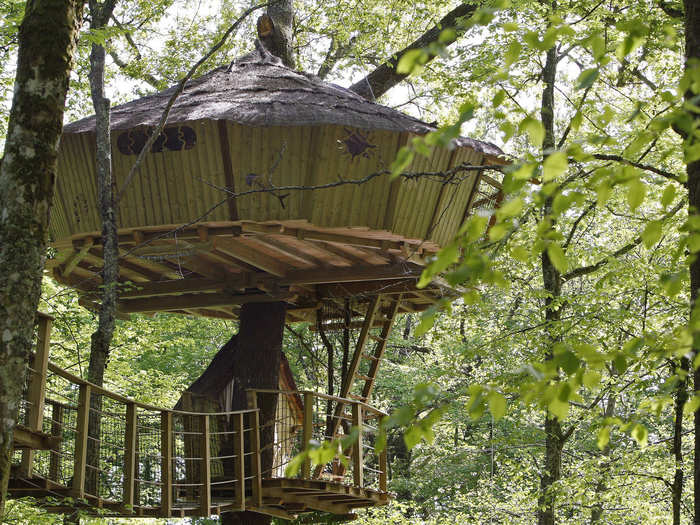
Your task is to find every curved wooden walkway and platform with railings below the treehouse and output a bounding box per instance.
[9,314,389,519]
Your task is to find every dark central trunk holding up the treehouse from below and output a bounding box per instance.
[221,303,286,525]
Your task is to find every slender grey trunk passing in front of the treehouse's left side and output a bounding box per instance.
[86,0,119,495]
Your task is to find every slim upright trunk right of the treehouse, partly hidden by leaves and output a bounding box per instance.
[537,42,564,525]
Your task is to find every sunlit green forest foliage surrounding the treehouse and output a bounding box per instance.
[0,0,700,524]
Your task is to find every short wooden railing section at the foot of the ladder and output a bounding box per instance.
[248,389,388,492]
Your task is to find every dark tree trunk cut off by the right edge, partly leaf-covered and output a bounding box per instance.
[683,0,700,525]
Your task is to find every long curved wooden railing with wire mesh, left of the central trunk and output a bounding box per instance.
[14,317,262,517]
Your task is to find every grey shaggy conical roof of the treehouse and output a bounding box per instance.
[64,46,503,156]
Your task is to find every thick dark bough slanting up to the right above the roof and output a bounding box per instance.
[350,2,480,101]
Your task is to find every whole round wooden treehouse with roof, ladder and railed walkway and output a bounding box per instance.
[10,41,502,518]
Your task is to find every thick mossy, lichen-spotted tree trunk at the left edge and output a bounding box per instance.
[0,0,82,517]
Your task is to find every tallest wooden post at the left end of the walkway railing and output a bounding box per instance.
[20,312,53,479]
